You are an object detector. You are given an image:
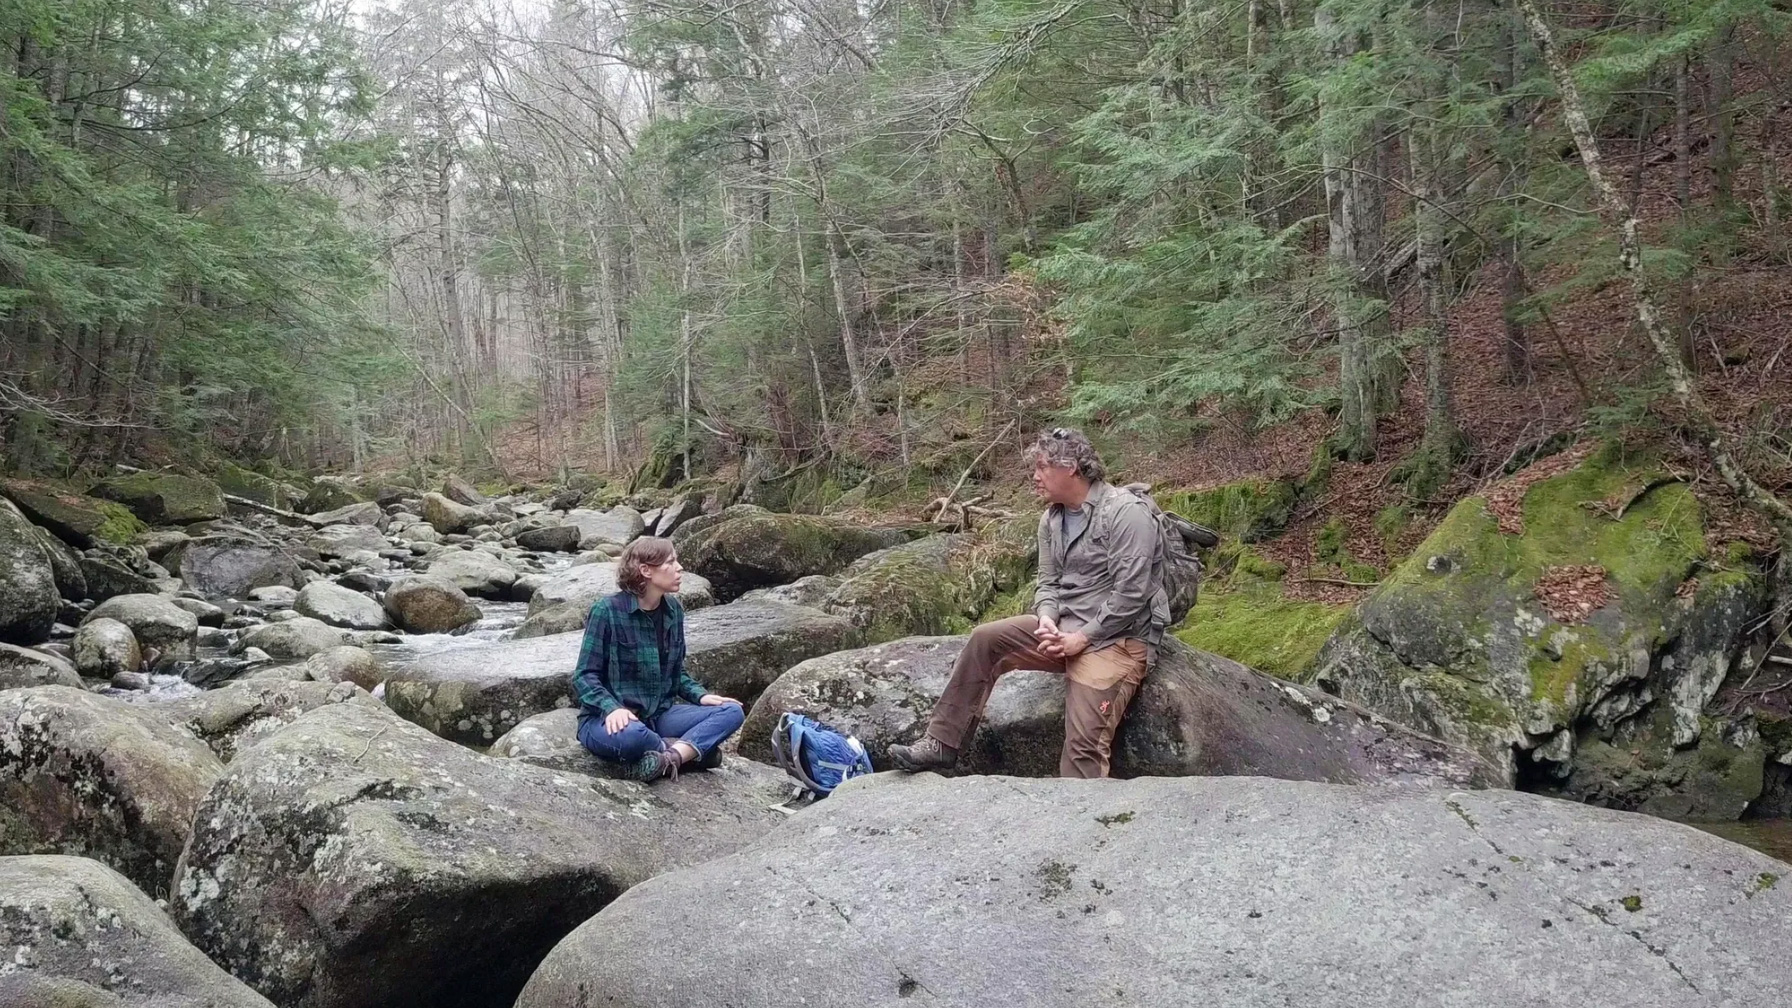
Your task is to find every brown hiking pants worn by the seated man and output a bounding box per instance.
[926,615,1145,778]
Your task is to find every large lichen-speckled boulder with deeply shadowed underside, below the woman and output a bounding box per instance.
[170,703,780,1008]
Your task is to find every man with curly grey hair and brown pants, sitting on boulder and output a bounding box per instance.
[889,427,1170,778]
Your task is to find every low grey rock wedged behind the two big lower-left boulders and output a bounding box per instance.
[154,678,382,762]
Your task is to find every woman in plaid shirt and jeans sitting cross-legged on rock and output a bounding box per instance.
[572,536,745,780]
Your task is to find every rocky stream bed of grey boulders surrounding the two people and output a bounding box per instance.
[0,474,1792,1008]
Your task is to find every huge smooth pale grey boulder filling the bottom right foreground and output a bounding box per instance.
[516,775,1792,1008]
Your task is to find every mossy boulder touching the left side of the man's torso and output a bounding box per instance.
[823,522,1038,642]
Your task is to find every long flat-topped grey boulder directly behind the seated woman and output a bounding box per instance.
[385,603,858,746]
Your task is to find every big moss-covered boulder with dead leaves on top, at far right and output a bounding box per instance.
[1315,443,1763,811]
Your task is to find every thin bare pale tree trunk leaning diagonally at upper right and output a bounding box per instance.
[1518,0,1792,543]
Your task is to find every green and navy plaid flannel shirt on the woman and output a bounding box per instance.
[572,592,710,723]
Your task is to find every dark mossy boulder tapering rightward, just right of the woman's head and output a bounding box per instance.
[674,506,910,601]
